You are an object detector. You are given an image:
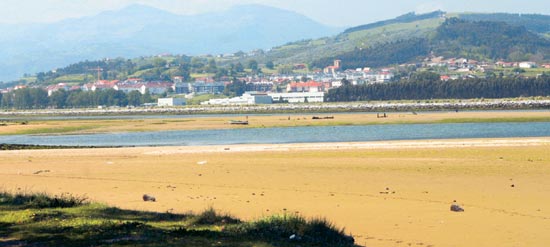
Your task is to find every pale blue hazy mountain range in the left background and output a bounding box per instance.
[0,5,342,81]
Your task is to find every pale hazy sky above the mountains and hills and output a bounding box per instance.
[0,0,550,26]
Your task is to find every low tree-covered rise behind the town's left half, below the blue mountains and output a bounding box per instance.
[22,55,268,87]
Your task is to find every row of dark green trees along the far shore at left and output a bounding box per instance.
[0,88,153,109]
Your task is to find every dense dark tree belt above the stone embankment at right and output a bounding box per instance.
[325,72,550,102]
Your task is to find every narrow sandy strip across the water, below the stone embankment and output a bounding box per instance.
[0,111,550,135]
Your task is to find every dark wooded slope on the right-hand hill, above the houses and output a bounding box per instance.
[312,18,550,69]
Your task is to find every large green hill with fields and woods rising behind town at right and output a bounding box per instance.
[247,11,550,68]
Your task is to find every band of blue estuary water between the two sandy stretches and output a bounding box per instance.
[0,122,550,146]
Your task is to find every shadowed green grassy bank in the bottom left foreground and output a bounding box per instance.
[0,192,354,247]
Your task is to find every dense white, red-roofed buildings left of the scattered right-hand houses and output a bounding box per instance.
[0,60,393,106]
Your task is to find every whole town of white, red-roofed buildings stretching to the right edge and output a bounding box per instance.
[1,56,550,106]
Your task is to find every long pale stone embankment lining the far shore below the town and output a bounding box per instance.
[0,97,550,116]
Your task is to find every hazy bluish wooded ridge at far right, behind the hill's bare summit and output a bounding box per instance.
[459,13,550,33]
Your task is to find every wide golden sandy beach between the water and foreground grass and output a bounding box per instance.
[0,138,550,246]
